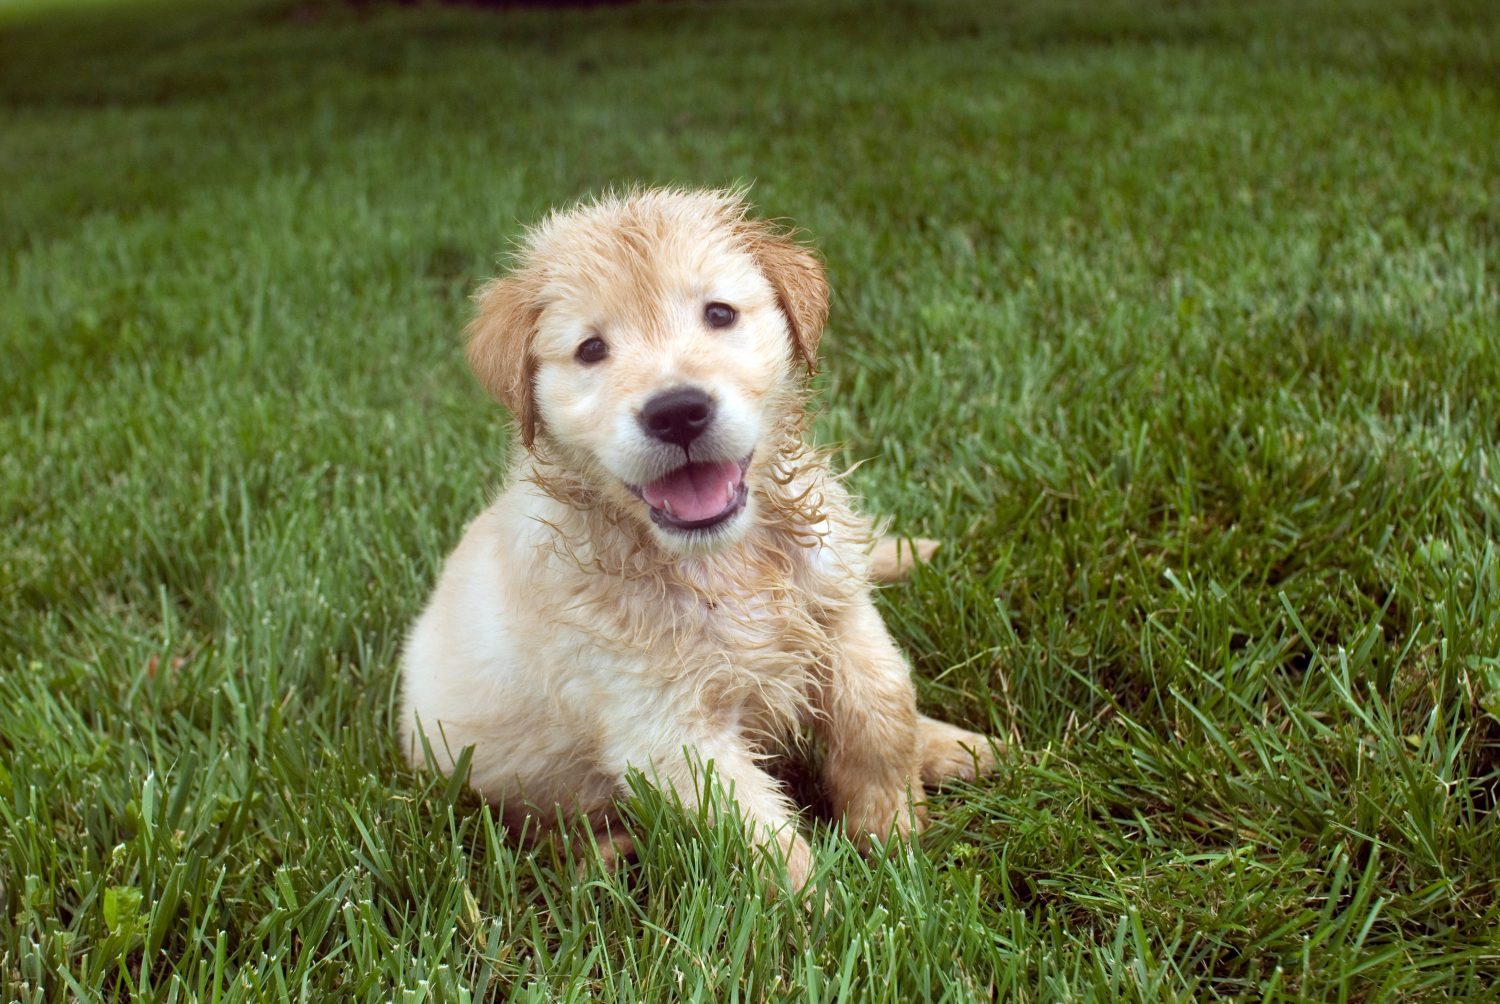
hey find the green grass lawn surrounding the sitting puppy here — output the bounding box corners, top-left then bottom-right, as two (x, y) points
(0, 0), (1500, 1001)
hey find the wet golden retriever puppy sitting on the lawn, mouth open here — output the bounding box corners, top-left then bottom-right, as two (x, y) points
(401, 189), (993, 885)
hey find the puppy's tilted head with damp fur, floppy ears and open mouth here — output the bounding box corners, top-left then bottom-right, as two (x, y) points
(468, 191), (828, 552)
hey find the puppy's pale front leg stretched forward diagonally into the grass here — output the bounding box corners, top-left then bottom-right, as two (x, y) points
(612, 726), (813, 888)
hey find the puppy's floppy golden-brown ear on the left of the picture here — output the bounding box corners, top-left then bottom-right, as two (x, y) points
(467, 276), (542, 449)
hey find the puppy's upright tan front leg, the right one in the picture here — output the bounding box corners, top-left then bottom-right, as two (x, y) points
(815, 596), (926, 846)
